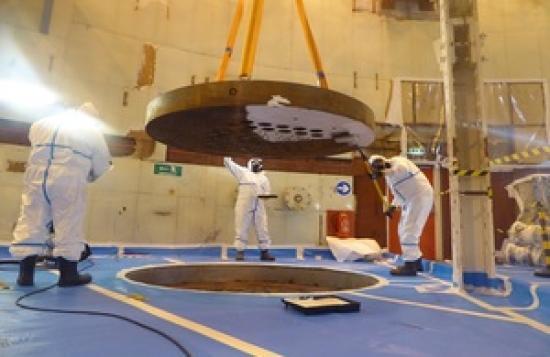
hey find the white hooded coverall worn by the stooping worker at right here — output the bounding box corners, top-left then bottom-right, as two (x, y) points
(384, 156), (433, 261)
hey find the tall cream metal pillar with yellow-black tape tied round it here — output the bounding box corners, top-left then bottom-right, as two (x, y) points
(440, 0), (495, 289)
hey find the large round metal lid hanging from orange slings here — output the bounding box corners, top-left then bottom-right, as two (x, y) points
(146, 80), (374, 158)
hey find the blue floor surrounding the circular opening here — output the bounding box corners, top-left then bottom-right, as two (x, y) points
(0, 250), (550, 357)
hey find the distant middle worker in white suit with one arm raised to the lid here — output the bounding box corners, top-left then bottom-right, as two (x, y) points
(223, 157), (275, 261)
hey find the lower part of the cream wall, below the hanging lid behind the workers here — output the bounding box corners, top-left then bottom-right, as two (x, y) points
(0, 145), (355, 245)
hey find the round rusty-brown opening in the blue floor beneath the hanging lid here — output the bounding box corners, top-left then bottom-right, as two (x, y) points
(123, 263), (379, 293)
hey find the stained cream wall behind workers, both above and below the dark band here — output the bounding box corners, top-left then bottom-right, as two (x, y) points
(0, 0), (550, 244)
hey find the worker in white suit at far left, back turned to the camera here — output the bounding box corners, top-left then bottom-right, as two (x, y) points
(10, 103), (111, 287)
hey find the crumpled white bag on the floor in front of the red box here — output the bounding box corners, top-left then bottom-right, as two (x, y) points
(327, 236), (381, 262)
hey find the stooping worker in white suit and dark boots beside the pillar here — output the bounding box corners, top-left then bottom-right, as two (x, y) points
(369, 155), (433, 276)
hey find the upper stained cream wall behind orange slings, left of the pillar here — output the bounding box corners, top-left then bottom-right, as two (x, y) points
(0, 0), (439, 127)
